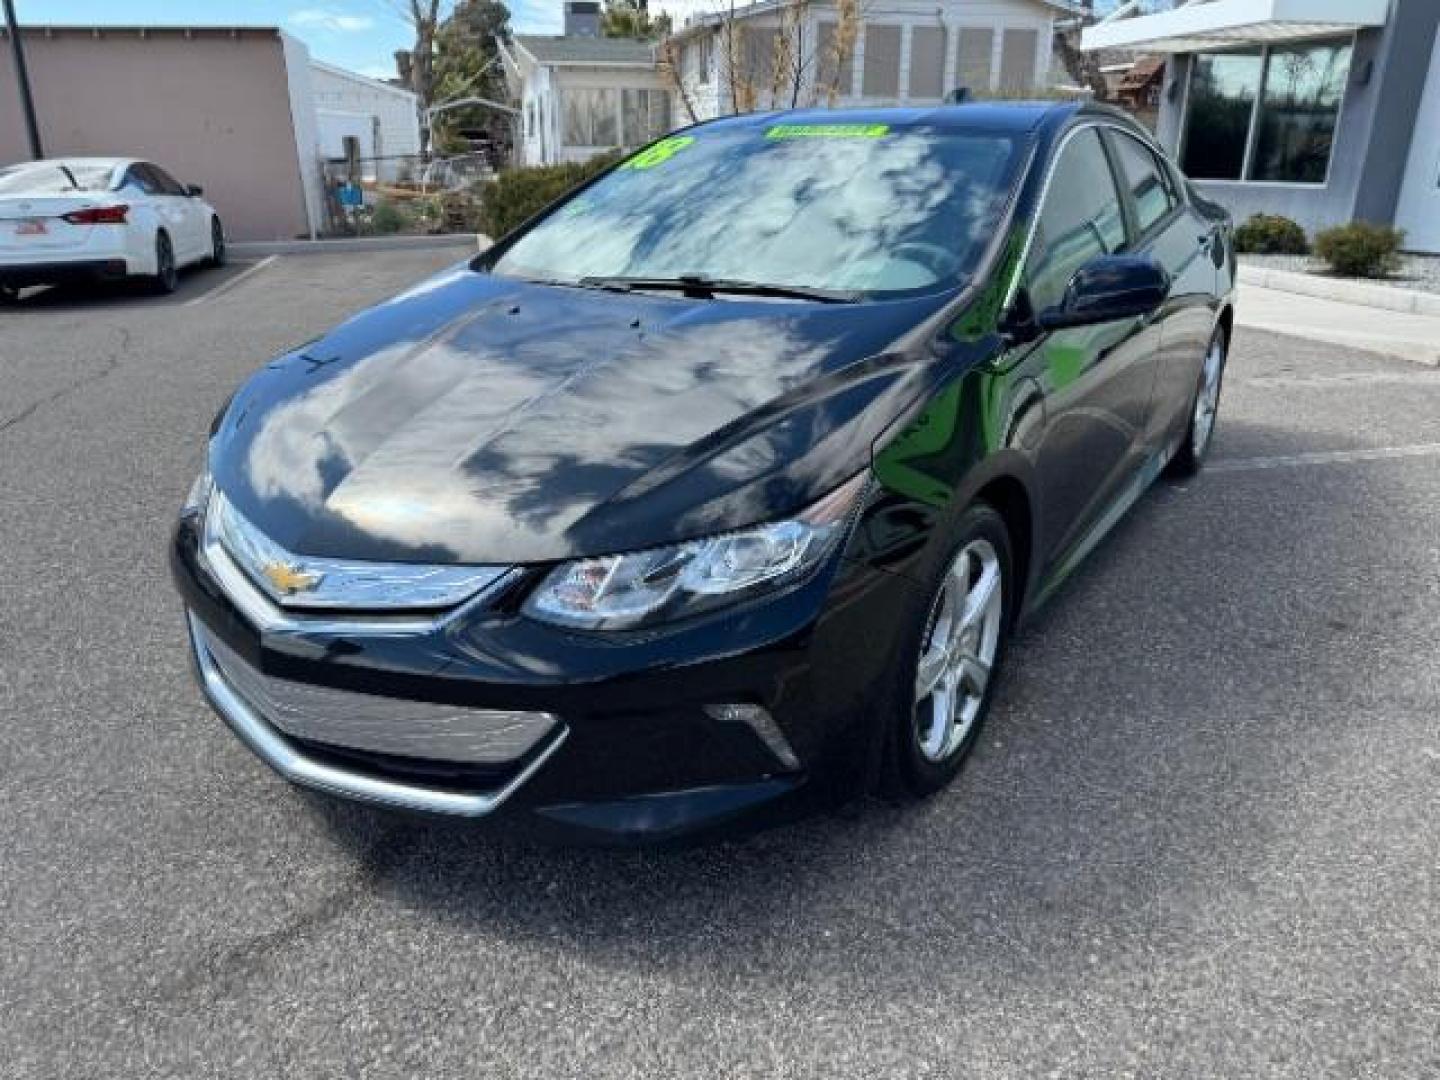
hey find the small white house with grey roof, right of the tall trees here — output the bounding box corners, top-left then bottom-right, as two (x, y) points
(500, 0), (674, 166)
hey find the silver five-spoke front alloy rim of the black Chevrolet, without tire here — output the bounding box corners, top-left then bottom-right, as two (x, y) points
(914, 539), (1005, 765)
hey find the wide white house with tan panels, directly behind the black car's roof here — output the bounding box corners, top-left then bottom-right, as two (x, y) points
(674, 0), (1077, 122)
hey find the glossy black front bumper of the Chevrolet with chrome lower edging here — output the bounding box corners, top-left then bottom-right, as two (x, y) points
(171, 509), (910, 842)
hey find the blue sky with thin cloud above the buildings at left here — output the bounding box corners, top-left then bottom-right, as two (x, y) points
(16, 0), (562, 78)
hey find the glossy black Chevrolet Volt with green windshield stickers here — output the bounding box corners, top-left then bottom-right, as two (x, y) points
(170, 104), (1236, 842)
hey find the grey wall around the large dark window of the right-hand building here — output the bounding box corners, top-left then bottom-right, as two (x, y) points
(1156, 0), (1440, 240)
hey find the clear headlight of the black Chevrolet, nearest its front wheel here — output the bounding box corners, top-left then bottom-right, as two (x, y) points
(524, 472), (867, 629)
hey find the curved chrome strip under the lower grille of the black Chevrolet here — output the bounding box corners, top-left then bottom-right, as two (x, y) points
(187, 615), (569, 818)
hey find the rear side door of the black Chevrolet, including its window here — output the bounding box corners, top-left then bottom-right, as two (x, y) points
(1106, 127), (1224, 454)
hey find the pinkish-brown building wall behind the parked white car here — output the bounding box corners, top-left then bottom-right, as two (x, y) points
(0, 29), (307, 239)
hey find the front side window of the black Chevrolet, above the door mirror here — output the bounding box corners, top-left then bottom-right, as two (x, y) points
(1025, 128), (1126, 311)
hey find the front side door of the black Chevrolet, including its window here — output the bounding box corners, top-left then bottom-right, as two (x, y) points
(1024, 124), (1161, 567)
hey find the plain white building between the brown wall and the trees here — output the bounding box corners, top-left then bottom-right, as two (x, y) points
(310, 60), (420, 180)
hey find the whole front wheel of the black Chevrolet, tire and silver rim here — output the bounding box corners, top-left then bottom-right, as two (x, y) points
(883, 503), (1017, 799)
